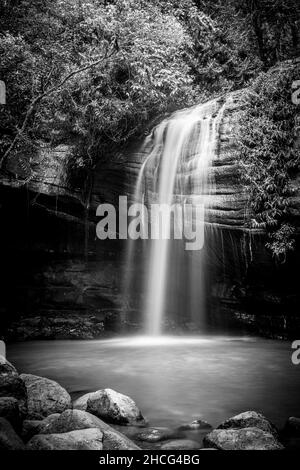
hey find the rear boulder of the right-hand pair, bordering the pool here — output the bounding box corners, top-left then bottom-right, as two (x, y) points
(217, 411), (278, 437)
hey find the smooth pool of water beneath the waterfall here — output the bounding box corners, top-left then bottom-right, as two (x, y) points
(7, 336), (300, 426)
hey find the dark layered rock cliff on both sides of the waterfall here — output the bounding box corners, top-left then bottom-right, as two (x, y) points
(0, 61), (300, 338)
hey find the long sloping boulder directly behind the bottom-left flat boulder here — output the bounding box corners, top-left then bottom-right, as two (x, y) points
(23, 410), (139, 450)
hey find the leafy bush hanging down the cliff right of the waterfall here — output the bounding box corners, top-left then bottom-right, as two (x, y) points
(238, 65), (300, 260)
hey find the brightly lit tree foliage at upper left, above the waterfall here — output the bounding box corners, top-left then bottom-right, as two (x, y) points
(0, 0), (196, 174)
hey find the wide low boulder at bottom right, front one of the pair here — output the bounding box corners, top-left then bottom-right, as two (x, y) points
(203, 427), (284, 450)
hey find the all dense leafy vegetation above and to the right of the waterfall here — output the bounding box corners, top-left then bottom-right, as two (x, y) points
(0, 0), (300, 255)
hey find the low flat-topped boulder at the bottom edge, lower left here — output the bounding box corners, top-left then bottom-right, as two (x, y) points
(26, 428), (103, 450)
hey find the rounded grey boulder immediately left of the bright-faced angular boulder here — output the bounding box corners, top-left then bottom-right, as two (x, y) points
(20, 374), (72, 419)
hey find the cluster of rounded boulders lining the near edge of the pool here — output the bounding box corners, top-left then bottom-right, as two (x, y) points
(0, 356), (300, 450)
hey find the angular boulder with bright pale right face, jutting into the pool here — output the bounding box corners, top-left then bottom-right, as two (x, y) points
(86, 388), (145, 424)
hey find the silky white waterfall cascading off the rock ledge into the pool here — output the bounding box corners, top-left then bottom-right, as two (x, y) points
(126, 101), (223, 336)
